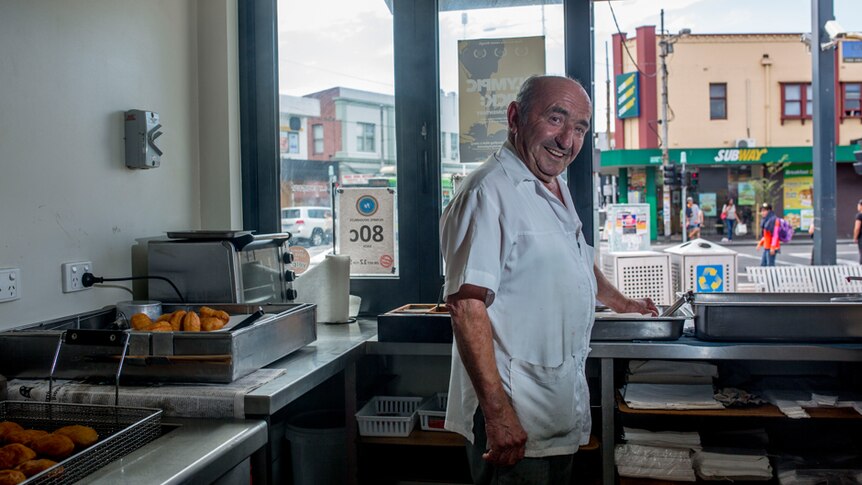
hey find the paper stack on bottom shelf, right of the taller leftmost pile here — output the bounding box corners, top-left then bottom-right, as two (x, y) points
(694, 450), (772, 481)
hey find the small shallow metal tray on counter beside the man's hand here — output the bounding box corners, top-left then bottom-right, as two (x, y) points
(590, 313), (686, 341)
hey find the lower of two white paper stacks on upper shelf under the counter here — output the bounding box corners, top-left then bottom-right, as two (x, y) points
(623, 383), (724, 409)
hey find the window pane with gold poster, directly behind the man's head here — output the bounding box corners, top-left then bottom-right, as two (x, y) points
(439, 1), (565, 210)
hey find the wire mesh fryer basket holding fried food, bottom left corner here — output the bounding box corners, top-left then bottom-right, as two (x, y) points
(0, 401), (162, 485)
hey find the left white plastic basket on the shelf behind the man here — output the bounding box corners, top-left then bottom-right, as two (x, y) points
(356, 396), (422, 437)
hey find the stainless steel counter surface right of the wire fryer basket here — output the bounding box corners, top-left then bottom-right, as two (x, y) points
(79, 418), (267, 485)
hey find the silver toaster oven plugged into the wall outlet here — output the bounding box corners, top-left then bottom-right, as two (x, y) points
(147, 231), (296, 303)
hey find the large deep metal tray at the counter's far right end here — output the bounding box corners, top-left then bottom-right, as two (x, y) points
(691, 293), (862, 342)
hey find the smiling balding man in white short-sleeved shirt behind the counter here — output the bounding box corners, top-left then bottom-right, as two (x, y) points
(440, 76), (657, 484)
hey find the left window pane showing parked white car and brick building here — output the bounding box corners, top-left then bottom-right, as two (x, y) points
(277, 0), (397, 264)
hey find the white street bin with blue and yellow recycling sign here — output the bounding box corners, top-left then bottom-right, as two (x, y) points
(664, 239), (737, 293)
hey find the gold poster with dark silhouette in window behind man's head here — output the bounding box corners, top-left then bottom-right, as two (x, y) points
(458, 36), (545, 163)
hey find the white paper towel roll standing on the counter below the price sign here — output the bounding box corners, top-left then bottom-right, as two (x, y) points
(293, 254), (350, 323)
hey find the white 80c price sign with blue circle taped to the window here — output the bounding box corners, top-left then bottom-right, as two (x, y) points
(335, 187), (398, 276)
